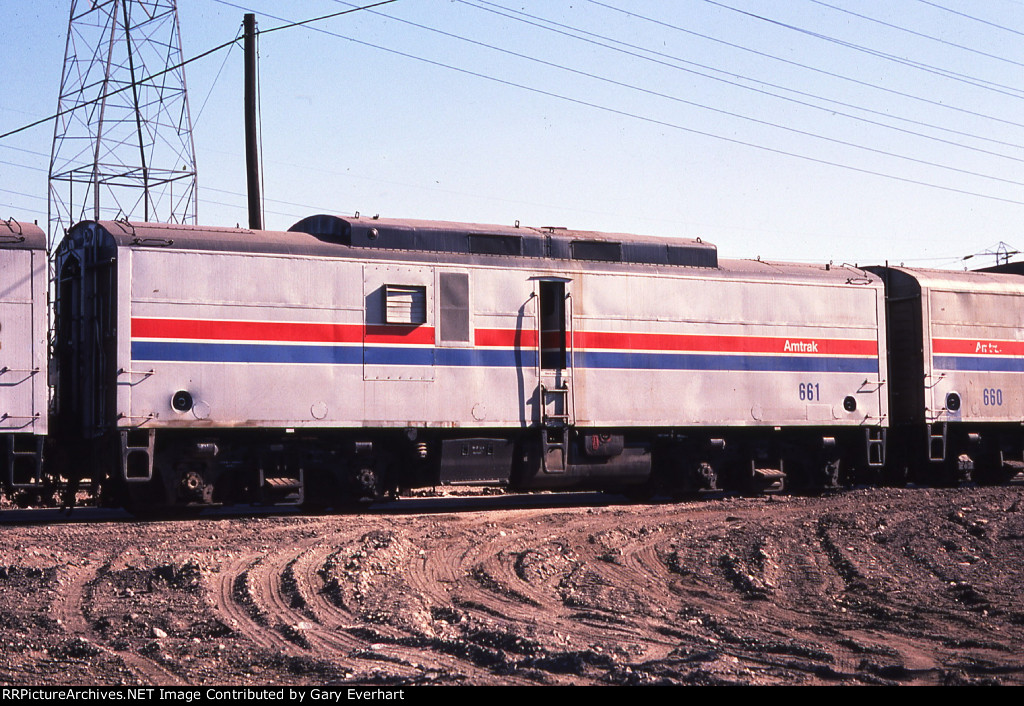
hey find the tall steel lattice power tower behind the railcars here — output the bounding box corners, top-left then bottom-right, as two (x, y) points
(48, 0), (197, 246)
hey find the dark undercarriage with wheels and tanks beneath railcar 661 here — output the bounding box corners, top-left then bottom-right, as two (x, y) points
(8, 418), (946, 513)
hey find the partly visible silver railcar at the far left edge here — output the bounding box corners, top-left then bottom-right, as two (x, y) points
(0, 220), (48, 490)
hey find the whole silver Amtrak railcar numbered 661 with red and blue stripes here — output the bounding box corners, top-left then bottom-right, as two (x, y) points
(55, 216), (888, 507)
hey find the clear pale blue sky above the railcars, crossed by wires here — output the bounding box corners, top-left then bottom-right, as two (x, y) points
(0, 0), (1024, 266)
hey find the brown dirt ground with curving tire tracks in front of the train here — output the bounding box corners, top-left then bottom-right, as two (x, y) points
(0, 488), (1024, 686)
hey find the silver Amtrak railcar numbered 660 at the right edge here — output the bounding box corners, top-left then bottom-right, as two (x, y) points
(872, 267), (1024, 483)
